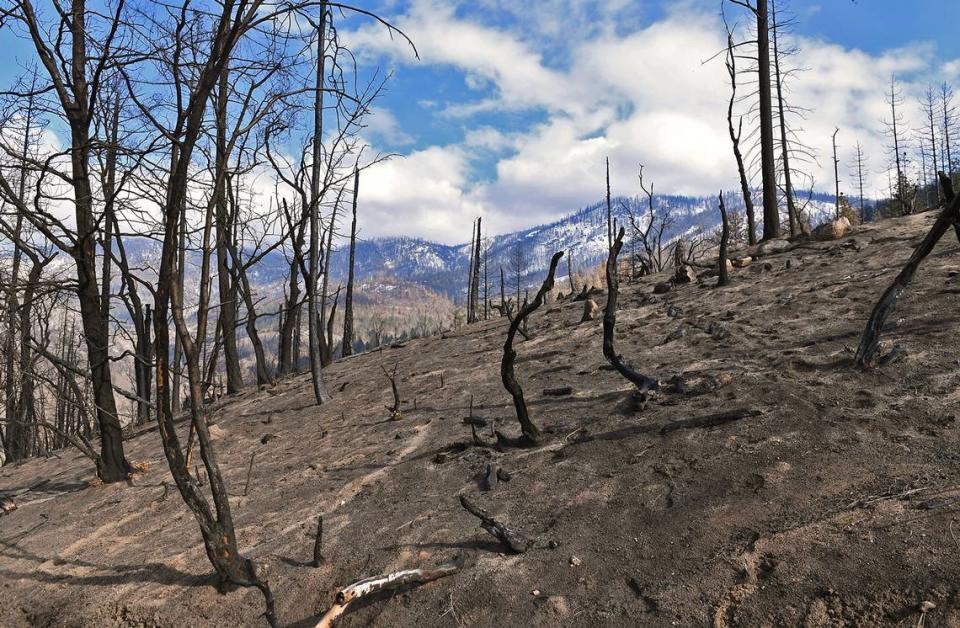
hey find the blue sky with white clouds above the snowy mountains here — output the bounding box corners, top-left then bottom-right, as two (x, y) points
(0, 0), (960, 242)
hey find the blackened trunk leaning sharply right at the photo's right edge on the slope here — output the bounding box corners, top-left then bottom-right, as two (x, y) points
(854, 172), (960, 368)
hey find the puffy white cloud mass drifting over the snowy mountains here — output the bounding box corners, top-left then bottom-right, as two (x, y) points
(345, 0), (960, 242)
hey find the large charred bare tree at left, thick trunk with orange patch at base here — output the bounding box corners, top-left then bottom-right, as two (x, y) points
(0, 0), (132, 482)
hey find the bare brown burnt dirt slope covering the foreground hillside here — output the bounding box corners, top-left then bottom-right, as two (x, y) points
(0, 214), (960, 628)
